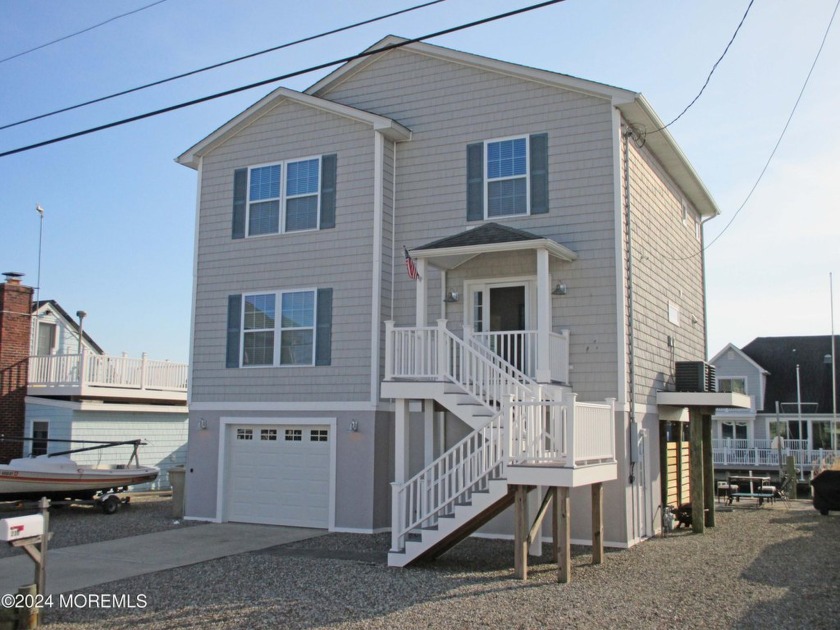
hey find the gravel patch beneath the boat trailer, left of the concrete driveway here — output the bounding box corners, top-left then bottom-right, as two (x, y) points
(0, 493), (201, 558)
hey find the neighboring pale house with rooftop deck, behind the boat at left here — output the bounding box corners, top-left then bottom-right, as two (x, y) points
(23, 300), (187, 490)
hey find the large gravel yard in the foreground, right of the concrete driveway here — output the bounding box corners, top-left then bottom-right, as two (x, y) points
(24, 501), (840, 630)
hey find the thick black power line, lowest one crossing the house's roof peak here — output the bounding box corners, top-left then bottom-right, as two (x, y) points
(0, 0), (566, 158)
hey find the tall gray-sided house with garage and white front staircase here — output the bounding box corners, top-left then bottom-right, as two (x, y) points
(178, 37), (718, 564)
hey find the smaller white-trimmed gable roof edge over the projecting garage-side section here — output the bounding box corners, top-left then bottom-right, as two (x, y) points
(175, 87), (411, 169)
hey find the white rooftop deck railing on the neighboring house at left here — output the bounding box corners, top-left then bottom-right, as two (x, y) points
(29, 353), (187, 392)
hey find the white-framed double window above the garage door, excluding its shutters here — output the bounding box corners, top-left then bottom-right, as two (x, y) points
(242, 290), (317, 366)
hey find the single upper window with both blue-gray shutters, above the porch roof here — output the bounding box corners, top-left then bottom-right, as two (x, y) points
(467, 133), (549, 221)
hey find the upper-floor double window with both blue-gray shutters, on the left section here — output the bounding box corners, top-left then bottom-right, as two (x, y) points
(232, 155), (337, 239)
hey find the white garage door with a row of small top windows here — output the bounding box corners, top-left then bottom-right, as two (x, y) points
(227, 425), (332, 528)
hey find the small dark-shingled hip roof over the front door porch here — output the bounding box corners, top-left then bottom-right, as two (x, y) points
(411, 222), (577, 270)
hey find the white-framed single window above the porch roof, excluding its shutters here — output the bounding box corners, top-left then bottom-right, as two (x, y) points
(485, 137), (529, 218)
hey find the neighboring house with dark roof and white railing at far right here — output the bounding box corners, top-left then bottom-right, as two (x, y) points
(711, 335), (840, 472)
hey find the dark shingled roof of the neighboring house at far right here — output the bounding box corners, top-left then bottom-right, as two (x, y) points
(743, 335), (840, 413)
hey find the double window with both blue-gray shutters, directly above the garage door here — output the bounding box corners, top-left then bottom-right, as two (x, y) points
(231, 289), (332, 367)
